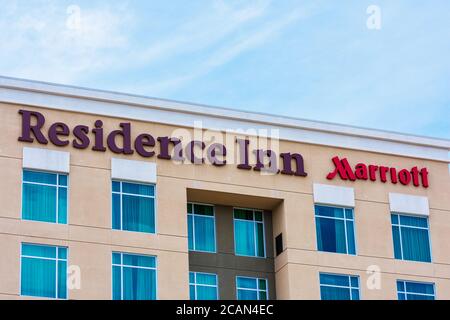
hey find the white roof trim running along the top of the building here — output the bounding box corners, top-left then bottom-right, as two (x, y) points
(0, 77), (450, 162)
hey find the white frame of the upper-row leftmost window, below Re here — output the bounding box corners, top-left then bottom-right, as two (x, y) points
(20, 168), (70, 226)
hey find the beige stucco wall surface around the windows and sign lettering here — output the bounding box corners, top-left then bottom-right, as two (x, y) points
(0, 104), (450, 299)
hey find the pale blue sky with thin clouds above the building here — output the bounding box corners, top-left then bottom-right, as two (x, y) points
(0, 0), (450, 139)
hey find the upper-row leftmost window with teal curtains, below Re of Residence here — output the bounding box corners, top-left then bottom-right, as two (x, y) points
(22, 170), (67, 224)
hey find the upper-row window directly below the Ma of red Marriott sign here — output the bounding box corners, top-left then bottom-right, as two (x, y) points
(315, 206), (356, 254)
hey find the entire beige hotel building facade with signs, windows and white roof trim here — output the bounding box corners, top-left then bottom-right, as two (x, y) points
(0, 78), (450, 300)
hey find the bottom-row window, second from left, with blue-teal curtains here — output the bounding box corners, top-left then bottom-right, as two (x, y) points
(112, 252), (156, 300)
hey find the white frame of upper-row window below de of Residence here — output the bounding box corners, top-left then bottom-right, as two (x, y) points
(110, 179), (158, 235)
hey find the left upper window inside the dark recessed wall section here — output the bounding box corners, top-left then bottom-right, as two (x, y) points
(187, 203), (216, 252)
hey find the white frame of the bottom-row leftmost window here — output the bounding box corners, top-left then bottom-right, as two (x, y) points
(19, 242), (69, 300)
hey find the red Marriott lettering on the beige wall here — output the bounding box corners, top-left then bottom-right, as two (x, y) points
(327, 157), (429, 188)
